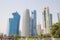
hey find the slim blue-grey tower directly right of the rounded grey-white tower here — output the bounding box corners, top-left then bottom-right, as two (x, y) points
(30, 10), (37, 36)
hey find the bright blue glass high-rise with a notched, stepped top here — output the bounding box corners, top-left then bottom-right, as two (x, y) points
(8, 12), (20, 36)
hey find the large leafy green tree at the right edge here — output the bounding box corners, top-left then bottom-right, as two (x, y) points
(50, 22), (60, 38)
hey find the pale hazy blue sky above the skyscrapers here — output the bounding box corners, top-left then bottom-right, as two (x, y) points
(0, 0), (60, 34)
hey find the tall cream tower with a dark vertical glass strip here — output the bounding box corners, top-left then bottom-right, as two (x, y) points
(42, 7), (50, 34)
